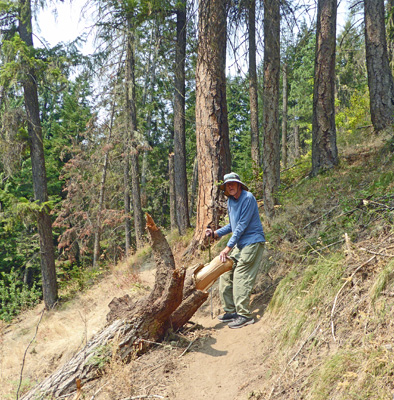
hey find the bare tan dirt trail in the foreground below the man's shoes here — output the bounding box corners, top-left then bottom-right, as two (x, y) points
(169, 317), (263, 400)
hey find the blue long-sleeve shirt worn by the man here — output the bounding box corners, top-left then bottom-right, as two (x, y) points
(216, 190), (265, 249)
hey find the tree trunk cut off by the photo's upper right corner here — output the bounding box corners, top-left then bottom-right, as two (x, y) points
(364, 0), (394, 131)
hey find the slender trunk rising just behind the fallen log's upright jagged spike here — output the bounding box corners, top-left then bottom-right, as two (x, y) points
(126, 21), (144, 249)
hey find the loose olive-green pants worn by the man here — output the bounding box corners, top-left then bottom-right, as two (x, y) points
(219, 242), (264, 318)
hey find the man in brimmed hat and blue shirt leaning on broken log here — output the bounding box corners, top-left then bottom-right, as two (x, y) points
(206, 172), (265, 328)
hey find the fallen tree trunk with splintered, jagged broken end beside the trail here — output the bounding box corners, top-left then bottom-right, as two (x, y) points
(21, 215), (233, 400)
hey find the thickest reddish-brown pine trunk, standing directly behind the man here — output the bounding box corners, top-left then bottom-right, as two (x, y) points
(192, 0), (231, 247)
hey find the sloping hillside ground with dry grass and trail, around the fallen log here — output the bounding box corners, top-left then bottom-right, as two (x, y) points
(0, 130), (394, 400)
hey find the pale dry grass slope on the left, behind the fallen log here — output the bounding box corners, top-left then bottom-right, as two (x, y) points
(0, 261), (153, 399)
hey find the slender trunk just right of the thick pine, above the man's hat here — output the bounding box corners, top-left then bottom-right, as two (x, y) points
(248, 0), (261, 191)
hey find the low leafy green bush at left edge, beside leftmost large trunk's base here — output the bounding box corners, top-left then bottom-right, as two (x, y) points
(0, 268), (41, 321)
